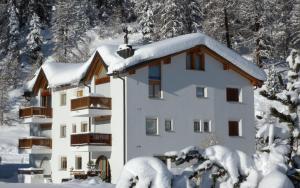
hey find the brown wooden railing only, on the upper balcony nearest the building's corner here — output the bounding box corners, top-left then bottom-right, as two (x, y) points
(71, 96), (111, 111)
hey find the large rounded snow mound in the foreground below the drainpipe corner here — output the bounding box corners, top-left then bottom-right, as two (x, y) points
(116, 157), (172, 188)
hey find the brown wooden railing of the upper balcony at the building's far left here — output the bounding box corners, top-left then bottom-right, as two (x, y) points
(19, 107), (52, 118)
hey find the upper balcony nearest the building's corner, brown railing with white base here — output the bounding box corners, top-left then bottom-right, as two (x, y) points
(71, 96), (111, 117)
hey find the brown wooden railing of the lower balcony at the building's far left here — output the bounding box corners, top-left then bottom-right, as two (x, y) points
(19, 138), (52, 149)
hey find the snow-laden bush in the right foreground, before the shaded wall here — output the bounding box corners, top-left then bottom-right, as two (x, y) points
(166, 143), (293, 188)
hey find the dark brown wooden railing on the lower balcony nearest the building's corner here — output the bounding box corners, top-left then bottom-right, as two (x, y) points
(71, 133), (111, 146)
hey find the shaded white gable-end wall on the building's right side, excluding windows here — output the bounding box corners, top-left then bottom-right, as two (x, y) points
(125, 54), (255, 159)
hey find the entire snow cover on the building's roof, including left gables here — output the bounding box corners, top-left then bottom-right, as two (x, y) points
(27, 33), (266, 89)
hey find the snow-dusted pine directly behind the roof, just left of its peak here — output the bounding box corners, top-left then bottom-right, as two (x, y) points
(159, 0), (186, 38)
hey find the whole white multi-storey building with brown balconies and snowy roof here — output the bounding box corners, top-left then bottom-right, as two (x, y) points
(19, 33), (266, 183)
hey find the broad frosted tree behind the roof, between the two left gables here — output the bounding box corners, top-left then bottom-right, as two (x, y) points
(52, 0), (90, 63)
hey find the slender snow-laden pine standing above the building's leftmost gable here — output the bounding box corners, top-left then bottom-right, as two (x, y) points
(27, 13), (43, 65)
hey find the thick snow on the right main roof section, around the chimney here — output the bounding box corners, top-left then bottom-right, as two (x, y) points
(97, 33), (266, 80)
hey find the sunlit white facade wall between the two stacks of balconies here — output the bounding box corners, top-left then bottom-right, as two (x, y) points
(51, 87), (89, 183)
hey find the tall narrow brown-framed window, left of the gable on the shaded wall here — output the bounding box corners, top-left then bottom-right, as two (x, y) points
(148, 64), (161, 98)
